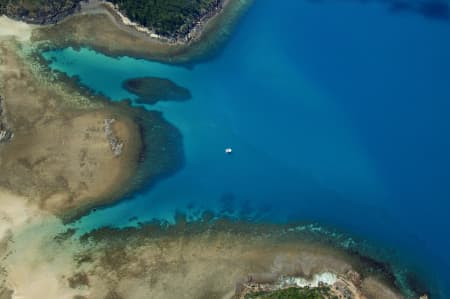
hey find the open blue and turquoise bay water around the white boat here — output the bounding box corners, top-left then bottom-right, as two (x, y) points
(45, 0), (450, 298)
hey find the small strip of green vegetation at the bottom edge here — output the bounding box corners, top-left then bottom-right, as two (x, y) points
(245, 287), (334, 299)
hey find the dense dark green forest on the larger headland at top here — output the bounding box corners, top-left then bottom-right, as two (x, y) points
(110, 0), (222, 37)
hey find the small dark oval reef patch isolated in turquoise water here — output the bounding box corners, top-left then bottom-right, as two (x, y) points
(122, 77), (192, 104)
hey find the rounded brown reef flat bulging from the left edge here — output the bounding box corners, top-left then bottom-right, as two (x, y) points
(0, 42), (141, 218)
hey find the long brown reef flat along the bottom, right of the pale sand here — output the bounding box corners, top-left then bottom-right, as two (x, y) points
(18, 220), (403, 299)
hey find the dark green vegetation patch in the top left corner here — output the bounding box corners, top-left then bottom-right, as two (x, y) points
(0, 0), (81, 24)
